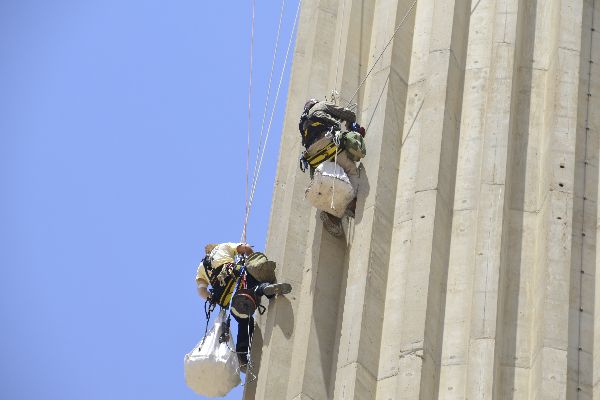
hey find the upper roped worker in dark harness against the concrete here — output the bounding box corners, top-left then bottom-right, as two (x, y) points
(298, 99), (366, 236)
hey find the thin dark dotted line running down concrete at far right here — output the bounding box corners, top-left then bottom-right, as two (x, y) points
(577, 0), (596, 399)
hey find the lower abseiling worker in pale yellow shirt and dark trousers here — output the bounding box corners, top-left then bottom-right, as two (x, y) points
(196, 243), (292, 365)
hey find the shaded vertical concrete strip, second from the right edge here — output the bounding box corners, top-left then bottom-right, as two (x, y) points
(493, 0), (537, 400)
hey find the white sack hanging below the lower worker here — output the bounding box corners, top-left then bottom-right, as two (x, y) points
(183, 310), (241, 397)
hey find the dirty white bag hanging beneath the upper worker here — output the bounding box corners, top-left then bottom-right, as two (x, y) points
(305, 161), (356, 218)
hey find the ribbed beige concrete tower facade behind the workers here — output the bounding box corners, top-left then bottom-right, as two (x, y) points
(245, 0), (600, 400)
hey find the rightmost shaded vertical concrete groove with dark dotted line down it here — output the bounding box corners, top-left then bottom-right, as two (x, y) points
(568, 1), (600, 399)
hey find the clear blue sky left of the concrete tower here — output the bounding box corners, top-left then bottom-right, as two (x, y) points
(0, 0), (298, 400)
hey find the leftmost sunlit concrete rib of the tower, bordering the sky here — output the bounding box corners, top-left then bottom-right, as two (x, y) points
(245, 0), (344, 399)
